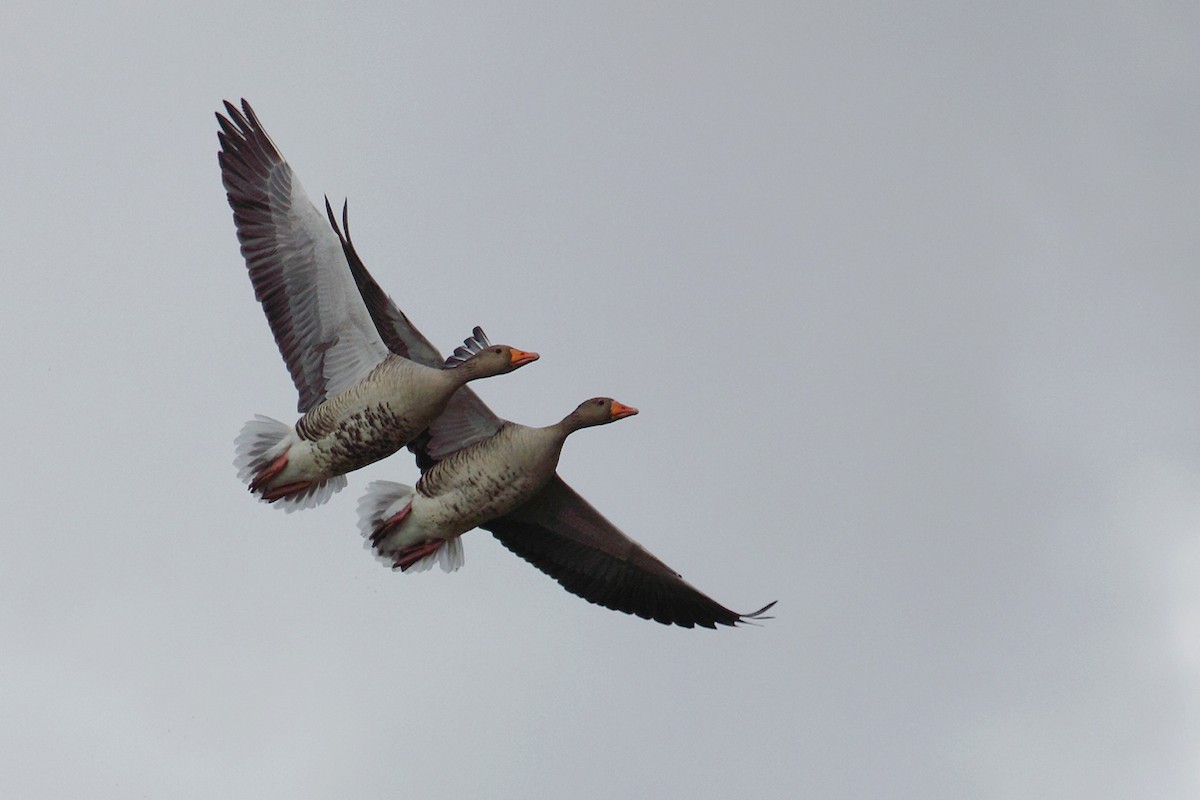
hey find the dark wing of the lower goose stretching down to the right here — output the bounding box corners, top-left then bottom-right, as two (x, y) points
(480, 475), (775, 627)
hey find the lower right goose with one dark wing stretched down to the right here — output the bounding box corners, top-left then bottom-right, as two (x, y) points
(341, 220), (775, 627)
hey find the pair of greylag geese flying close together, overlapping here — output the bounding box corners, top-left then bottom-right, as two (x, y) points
(217, 101), (774, 627)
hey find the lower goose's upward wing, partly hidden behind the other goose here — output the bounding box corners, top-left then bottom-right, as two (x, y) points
(325, 198), (504, 471)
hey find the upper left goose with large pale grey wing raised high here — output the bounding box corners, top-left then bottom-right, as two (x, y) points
(216, 101), (538, 511)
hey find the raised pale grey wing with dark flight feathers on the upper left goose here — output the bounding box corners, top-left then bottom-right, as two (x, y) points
(217, 101), (388, 413)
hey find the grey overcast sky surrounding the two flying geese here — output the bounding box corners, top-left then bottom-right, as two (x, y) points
(0, 0), (1200, 800)
